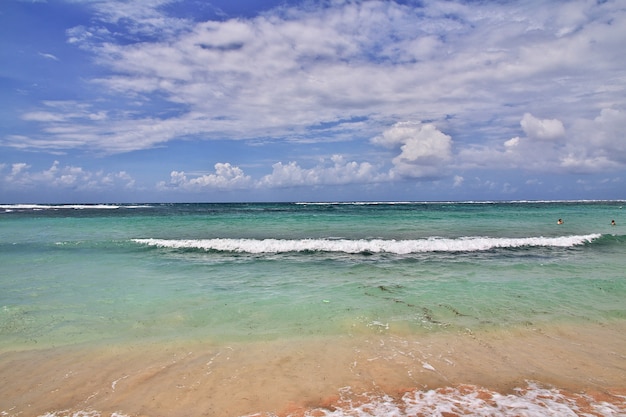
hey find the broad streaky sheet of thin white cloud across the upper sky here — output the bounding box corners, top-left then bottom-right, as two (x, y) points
(11, 0), (626, 156)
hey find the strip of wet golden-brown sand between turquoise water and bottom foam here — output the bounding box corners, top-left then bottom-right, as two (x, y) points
(0, 321), (626, 417)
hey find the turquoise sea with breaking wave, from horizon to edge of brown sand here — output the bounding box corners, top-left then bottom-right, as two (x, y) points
(0, 201), (626, 350)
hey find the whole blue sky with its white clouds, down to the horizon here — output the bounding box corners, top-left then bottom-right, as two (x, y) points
(0, 0), (626, 203)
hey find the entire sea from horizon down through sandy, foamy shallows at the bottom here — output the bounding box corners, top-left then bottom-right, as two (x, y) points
(0, 201), (626, 417)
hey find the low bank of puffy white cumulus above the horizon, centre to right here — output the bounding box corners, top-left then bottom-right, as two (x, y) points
(149, 105), (624, 193)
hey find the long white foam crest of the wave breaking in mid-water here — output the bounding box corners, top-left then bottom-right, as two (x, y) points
(133, 234), (601, 254)
